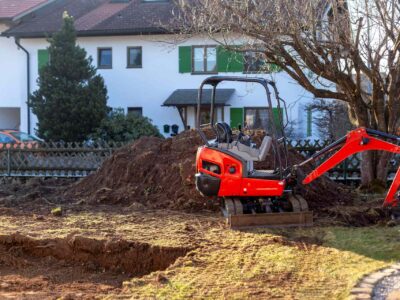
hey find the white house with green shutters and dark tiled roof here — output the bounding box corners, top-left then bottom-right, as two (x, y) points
(0, 0), (317, 137)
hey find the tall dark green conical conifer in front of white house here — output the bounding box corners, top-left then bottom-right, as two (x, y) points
(29, 14), (109, 142)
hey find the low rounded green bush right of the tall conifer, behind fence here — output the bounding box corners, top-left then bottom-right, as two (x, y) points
(90, 108), (162, 142)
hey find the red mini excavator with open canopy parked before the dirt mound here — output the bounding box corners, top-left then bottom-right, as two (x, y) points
(195, 76), (400, 228)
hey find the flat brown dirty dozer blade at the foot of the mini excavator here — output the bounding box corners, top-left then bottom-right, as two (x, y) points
(227, 211), (313, 229)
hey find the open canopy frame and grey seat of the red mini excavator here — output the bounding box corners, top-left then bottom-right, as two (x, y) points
(197, 76), (287, 179)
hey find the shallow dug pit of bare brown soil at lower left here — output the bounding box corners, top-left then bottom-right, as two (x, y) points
(0, 234), (189, 299)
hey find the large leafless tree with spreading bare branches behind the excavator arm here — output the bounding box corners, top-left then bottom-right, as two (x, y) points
(178, 0), (400, 186)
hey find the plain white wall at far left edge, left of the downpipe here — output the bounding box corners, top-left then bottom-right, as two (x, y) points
(0, 23), (26, 128)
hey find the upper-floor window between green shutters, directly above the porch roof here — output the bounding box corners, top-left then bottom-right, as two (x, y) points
(192, 46), (217, 73)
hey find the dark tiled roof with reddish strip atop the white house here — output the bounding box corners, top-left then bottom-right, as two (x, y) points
(4, 0), (176, 37)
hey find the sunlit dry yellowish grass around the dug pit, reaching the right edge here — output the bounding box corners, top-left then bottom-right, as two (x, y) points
(0, 208), (400, 299)
